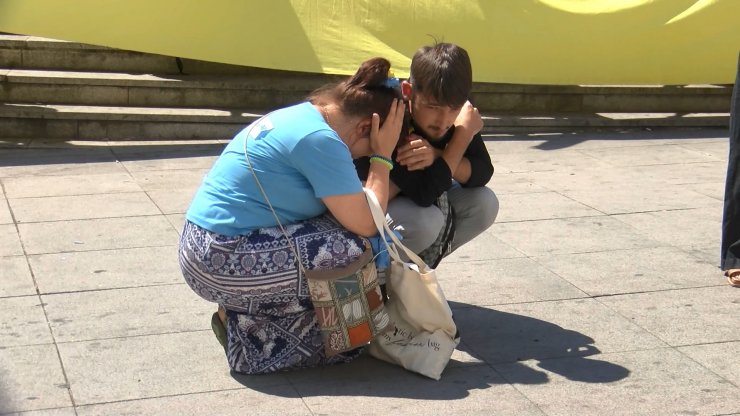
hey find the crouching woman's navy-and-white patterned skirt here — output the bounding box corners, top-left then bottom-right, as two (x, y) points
(179, 216), (366, 374)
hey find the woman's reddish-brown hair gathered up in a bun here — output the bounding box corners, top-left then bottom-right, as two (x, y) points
(308, 58), (402, 123)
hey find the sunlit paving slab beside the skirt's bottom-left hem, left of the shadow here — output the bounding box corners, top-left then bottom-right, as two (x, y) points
(58, 330), (287, 405)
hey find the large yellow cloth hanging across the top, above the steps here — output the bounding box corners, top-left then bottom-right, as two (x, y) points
(0, 0), (740, 84)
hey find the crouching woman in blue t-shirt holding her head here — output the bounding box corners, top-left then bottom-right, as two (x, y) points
(179, 58), (404, 373)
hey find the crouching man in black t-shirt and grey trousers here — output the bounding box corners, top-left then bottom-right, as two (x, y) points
(355, 43), (499, 264)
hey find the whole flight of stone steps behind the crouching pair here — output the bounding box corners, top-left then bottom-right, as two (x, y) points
(0, 34), (731, 140)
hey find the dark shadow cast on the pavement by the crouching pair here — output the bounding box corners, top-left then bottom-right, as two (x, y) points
(232, 302), (630, 400)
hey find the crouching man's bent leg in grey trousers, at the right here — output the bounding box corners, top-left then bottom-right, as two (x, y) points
(447, 183), (499, 251)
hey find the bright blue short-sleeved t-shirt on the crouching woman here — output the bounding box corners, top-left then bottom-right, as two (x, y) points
(185, 102), (362, 236)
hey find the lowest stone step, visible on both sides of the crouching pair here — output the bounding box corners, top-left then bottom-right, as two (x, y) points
(0, 104), (729, 140)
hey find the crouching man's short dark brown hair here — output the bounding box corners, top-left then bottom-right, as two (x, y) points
(409, 43), (473, 107)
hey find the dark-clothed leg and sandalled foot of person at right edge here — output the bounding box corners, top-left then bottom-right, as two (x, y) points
(720, 50), (740, 287)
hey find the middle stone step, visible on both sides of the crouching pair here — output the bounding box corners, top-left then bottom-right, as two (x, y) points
(0, 68), (732, 113)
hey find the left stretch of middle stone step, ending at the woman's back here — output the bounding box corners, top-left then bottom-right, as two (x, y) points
(0, 69), (338, 108)
